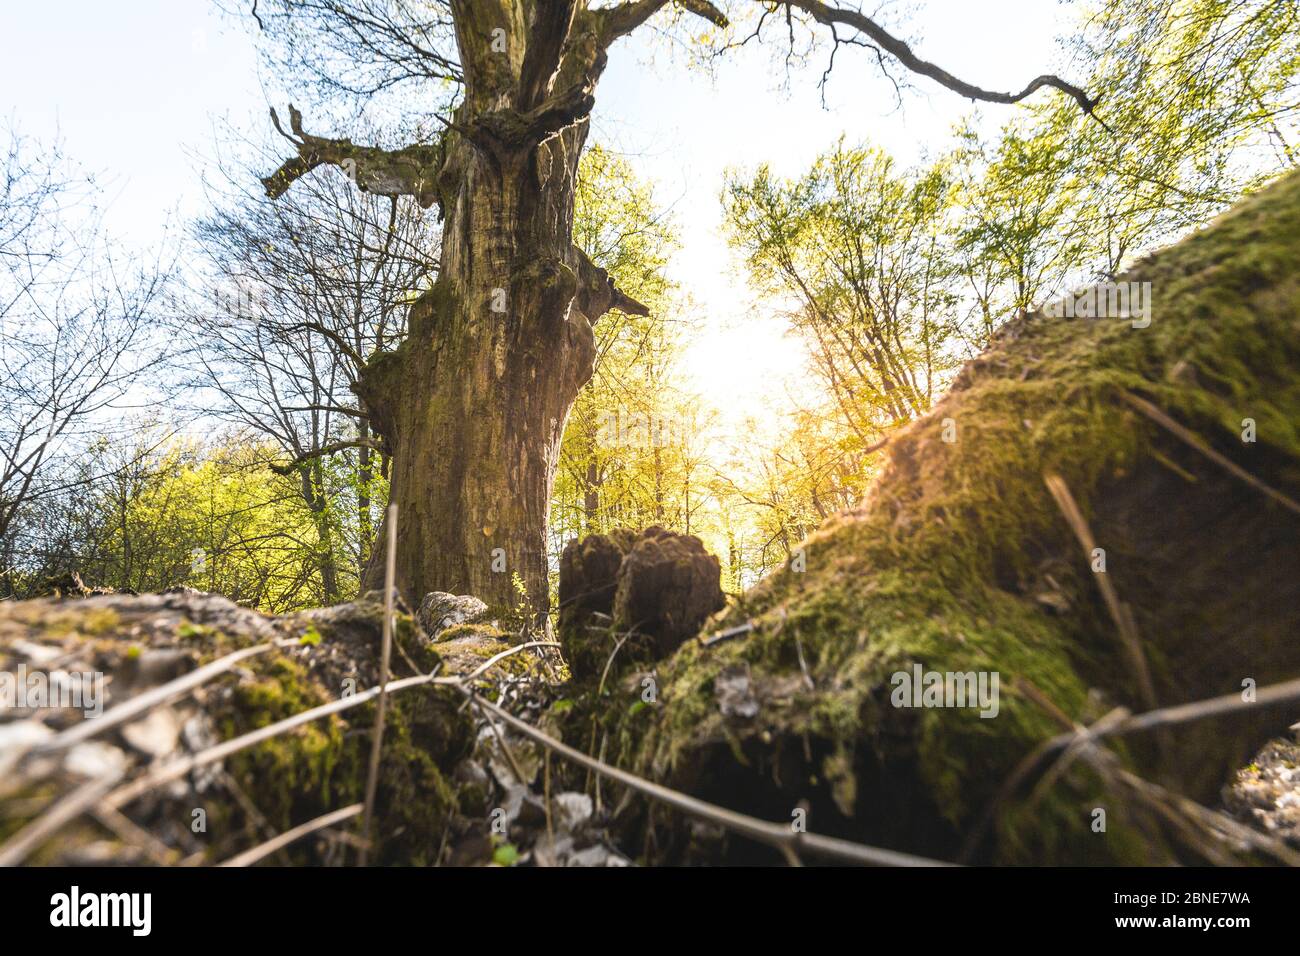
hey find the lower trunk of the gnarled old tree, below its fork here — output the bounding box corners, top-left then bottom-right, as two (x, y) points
(365, 129), (595, 607)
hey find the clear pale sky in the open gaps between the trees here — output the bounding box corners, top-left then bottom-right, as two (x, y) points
(0, 0), (1073, 418)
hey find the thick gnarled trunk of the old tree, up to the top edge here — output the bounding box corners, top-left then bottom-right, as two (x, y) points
(358, 3), (638, 614)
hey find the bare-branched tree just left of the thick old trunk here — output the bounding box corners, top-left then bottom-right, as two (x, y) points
(189, 140), (438, 601)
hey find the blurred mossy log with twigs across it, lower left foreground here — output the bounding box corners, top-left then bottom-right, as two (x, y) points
(0, 592), (478, 864)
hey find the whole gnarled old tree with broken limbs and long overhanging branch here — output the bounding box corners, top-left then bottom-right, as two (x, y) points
(254, 0), (1095, 611)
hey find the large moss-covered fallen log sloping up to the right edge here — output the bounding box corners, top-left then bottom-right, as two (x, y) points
(567, 174), (1300, 864)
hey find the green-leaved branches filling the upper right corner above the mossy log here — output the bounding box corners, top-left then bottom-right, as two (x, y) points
(953, 0), (1300, 325)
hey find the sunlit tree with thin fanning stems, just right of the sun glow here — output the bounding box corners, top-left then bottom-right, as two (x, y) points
(725, 143), (956, 447)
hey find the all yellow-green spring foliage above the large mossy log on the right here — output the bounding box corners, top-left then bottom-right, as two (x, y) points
(720, 0), (1300, 590)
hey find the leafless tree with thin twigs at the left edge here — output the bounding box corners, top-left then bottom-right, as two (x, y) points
(0, 134), (169, 566)
